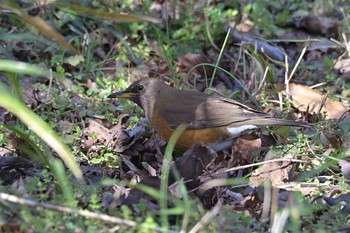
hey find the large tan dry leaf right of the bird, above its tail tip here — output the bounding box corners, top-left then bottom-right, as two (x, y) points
(289, 83), (349, 119)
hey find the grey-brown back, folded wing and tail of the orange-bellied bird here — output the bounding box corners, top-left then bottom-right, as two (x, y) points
(156, 85), (306, 130)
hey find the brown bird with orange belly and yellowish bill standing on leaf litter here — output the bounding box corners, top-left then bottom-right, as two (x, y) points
(107, 78), (308, 150)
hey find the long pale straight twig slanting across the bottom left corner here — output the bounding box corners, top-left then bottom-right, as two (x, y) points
(0, 193), (168, 232)
